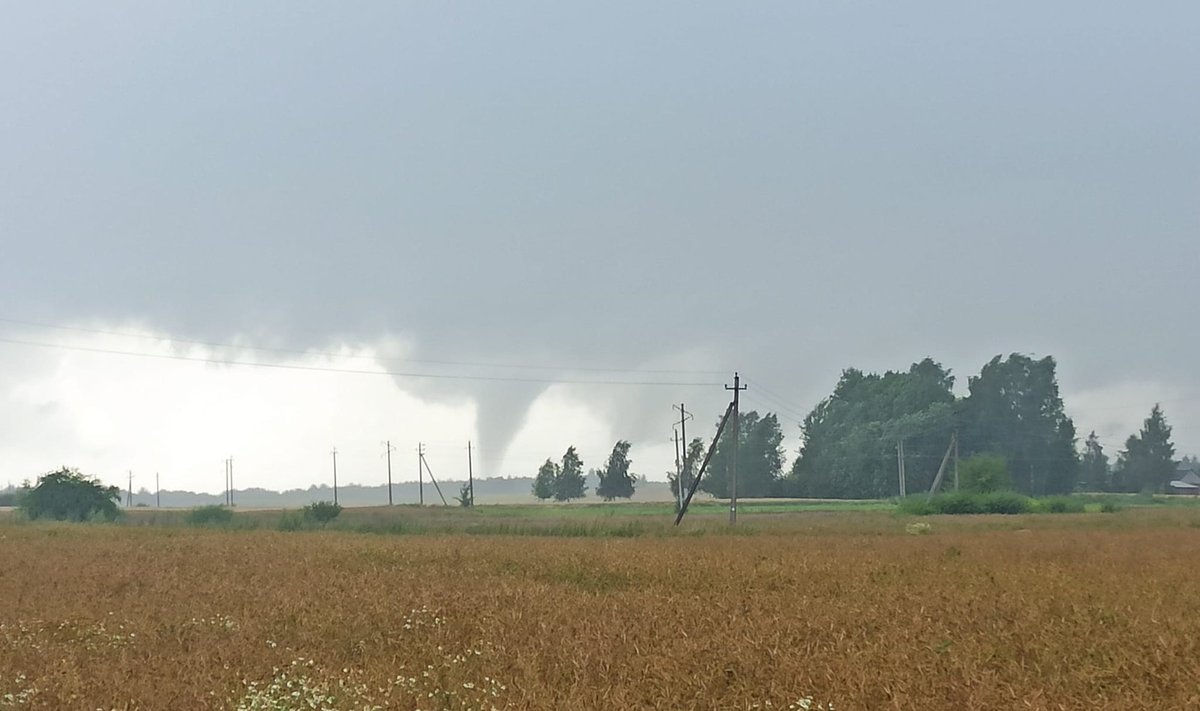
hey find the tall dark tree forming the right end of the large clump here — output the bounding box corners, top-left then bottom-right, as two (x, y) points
(959, 353), (1079, 495)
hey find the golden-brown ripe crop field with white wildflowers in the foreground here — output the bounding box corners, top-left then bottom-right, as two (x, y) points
(0, 510), (1200, 710)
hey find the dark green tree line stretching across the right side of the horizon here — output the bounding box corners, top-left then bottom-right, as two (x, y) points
(668, 353), (1177, 498)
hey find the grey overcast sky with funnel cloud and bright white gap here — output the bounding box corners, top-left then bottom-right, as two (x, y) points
(0, 0), (1200, 491)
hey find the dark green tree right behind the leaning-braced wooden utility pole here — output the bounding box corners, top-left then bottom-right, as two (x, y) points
(700, 410), (784, 498)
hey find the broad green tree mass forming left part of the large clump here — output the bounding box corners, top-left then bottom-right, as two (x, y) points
(785, 358), (954, 498)
